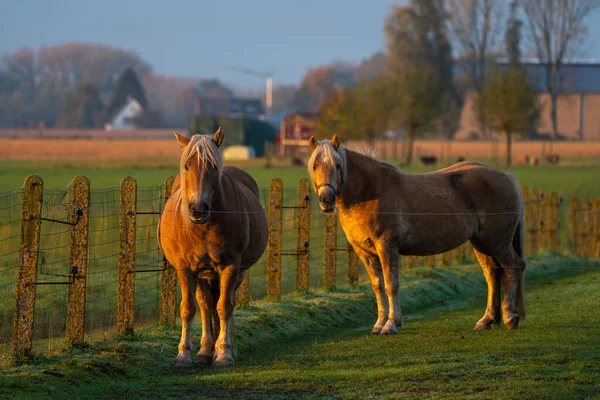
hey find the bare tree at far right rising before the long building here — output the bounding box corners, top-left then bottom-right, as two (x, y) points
(520, 0), (600, 138)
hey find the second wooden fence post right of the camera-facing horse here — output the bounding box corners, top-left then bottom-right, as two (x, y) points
(296, 178), (310, 292)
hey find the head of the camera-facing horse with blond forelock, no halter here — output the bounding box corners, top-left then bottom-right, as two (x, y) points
(175, 128), (224, 224)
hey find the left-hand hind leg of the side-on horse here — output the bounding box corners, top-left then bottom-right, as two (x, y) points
(475, 249), (503, 331)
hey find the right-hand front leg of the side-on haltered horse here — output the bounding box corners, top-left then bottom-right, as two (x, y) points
(377, 241), (402, 335)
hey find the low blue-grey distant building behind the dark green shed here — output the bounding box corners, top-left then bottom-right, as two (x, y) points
(194, 96), (265, 119)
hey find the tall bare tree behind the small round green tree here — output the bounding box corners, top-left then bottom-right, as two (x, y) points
(447, 0), (507, 136)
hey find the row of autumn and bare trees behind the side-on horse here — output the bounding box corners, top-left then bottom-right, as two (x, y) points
(314, 0), (600, 165)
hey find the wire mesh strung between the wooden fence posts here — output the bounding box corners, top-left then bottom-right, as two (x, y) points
(0, 177), (598, 352)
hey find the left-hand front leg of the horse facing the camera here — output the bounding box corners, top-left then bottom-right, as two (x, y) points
(175, 268), (198, 367)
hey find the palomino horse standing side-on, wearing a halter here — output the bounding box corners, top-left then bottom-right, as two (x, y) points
(308, 135), (525, 335)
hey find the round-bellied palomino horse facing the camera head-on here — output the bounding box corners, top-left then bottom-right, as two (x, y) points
(158, 128), (268, 367)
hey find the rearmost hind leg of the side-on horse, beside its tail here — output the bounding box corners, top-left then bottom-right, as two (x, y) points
(494, 244), (525, 329)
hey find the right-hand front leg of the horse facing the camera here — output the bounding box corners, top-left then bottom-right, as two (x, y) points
(215, 263), (241, 366)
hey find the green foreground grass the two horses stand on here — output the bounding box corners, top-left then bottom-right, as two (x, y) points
(0, 256), (600, 399)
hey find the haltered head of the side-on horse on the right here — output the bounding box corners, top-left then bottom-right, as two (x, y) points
(308, 135), (346, 213)
